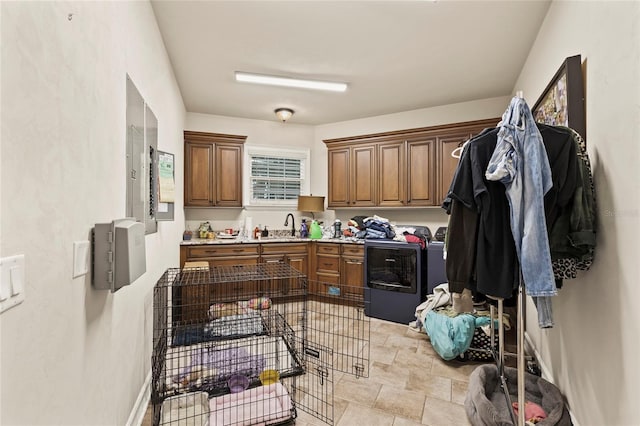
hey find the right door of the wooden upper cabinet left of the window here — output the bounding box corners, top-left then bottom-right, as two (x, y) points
(215, 144), (242, 207)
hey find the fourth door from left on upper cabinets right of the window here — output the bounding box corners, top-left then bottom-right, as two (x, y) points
(407, 138), (436, 206)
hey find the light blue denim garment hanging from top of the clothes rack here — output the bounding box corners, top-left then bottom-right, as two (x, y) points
(485, 97), (557, 327)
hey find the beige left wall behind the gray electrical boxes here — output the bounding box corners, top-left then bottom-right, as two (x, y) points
(0, 2), (185, 425)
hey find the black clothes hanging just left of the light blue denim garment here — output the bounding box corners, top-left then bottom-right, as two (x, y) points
(442, 128), (518, 299)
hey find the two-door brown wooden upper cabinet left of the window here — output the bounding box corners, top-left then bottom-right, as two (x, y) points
(184, 131), (247, 207)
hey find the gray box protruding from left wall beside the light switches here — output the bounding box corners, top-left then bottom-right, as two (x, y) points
(92, 218), (147, 293)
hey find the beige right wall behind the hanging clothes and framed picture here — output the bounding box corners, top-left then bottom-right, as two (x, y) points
(514, 1), (640, 426)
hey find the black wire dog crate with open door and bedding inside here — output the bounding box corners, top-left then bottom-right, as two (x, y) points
(151, 263), (369, 426)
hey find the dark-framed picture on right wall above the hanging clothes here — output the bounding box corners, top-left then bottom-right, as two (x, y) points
(532, 55), (587, 141)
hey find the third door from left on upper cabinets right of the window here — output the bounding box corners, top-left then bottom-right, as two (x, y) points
(376, 141), (406, 207)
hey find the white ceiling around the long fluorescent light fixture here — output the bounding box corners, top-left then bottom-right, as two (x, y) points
(152, 0), (550, 124)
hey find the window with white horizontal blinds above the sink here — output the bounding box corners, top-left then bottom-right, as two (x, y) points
(250, 154), (305, 203)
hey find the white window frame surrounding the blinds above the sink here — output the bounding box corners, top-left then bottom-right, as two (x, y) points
(243, 145), (310, 209)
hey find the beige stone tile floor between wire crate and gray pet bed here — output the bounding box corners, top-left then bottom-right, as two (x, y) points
(143, 318), (490, 426)
